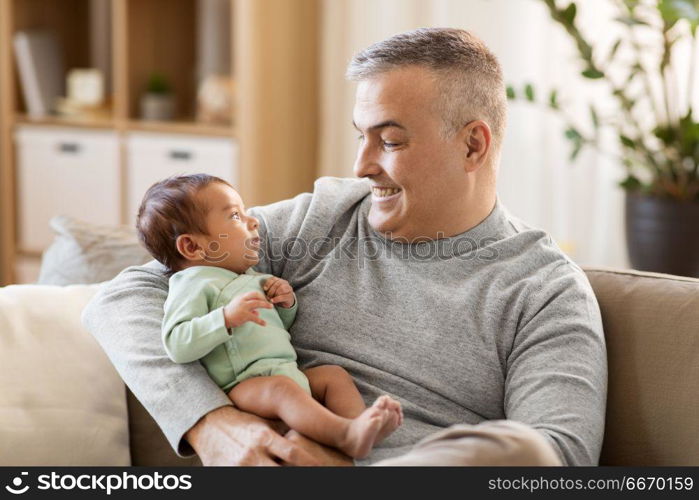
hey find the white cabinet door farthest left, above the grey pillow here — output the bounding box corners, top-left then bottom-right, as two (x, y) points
(15, 126), (121, 252)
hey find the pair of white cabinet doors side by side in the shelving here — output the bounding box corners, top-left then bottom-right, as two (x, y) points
(15, 125), (238, 253)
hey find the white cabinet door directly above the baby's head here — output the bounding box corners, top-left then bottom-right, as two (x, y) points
(127, 133), (238, 224)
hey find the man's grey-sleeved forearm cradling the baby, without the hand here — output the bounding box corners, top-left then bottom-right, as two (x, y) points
(83, 264), (231, 454)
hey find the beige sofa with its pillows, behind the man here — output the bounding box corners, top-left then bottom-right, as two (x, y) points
(0, 217), (699, 466)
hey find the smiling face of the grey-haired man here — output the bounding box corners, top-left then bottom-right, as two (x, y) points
(354, 66), (468, 240)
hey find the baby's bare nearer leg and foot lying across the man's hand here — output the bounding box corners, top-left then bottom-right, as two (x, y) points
(228, 375), (390, 458)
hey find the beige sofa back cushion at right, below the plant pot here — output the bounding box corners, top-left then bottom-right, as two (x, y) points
(585, 269), (699, 465)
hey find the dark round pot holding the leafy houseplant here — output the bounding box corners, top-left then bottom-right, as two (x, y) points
(626, 192), (699, 278)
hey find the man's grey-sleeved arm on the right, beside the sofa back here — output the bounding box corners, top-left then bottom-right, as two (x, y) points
(504, 263), (607, 465)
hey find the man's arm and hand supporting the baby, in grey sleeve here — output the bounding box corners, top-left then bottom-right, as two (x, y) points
(83, 262), (317, 465)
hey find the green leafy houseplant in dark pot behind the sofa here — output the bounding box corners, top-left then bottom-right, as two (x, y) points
(507, 0), (699, 277)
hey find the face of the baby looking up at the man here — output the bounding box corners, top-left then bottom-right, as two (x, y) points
(197, 182), (260, 274)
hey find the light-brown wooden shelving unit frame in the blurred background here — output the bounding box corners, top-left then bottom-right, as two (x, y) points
(0, 0), (320, 285)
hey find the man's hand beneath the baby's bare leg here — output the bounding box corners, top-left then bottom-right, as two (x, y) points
(185, 406), (320, 466)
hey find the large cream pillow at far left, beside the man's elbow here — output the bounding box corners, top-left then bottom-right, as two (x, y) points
(0, 285), (130, 466)
